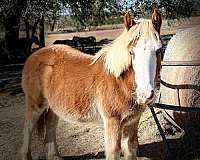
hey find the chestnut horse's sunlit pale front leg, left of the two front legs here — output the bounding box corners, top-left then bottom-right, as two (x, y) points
(104, 117), (121, 160)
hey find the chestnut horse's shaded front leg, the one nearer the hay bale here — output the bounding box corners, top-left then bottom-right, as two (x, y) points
(122, 117), (140, 160)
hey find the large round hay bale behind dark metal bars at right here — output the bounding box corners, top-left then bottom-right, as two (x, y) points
(160, 26), (200, 129)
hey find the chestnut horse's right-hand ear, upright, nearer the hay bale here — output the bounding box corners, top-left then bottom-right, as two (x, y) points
(151, 8), (162, 34)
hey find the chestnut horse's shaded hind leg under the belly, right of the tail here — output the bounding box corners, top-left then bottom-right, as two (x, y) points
(45, 109), (62, 160)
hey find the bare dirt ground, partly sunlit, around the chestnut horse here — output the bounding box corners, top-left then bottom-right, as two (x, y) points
(0, 17), (200, 160)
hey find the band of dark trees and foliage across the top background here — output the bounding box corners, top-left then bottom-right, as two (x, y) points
(0, 0), (200, 60)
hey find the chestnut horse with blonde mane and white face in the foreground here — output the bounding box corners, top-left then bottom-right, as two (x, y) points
(21, 10), (162, 160)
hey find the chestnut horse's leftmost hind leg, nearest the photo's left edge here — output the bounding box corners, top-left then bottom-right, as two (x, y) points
(21, 97), (45, 160)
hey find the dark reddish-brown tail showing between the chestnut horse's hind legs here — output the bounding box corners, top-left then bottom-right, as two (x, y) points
(37, 110), (48, 139)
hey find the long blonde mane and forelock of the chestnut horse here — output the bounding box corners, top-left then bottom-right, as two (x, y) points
(92, 19), (159, 78)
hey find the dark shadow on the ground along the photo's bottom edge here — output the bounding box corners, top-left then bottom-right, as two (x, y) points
(50, 137), (200, 160)
